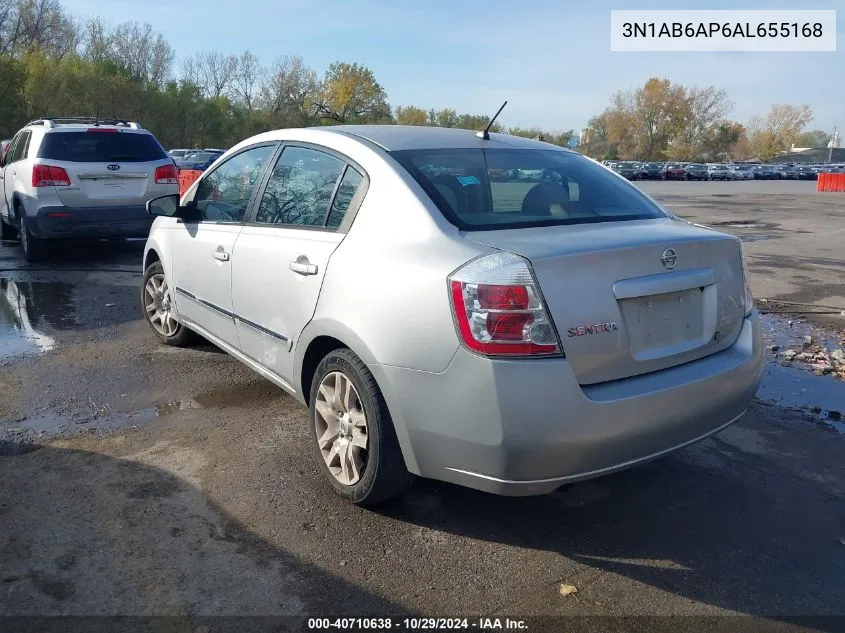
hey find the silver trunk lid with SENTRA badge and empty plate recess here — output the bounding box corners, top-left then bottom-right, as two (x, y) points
(465, 219), (744, 385)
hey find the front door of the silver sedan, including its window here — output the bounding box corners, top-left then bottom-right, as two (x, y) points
(173, 144), (276, 347)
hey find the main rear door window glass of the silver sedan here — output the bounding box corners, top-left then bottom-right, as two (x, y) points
(255, 147), (345, 226)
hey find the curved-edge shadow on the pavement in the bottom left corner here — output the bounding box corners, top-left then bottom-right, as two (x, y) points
(0, 442), (408, 632)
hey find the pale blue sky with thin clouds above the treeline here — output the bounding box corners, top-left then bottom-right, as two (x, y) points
(63, 0), (845, 131)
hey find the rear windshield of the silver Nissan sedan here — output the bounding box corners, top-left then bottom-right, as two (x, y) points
(392, 149), (665, 230)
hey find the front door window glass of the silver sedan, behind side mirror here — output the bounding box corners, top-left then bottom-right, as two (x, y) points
(194, 145), (276, 222)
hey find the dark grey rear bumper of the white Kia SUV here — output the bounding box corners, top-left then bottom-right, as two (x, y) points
(27, 206), (155, 239)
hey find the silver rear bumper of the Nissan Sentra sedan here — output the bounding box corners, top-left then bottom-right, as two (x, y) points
(371, 313), (763, 496)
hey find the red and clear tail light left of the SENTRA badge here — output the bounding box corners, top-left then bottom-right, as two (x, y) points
(449, 253), (561, 356)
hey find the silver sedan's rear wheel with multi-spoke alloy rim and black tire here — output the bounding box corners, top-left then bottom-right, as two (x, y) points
(308, 348), (413, 506)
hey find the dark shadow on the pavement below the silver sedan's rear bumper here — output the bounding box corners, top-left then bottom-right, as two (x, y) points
(381, 407), (845, 616)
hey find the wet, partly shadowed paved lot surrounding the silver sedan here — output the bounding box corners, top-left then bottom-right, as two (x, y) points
(0, 182), (845, 631)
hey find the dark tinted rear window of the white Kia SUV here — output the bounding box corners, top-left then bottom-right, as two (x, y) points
(38, 132), (167, 163)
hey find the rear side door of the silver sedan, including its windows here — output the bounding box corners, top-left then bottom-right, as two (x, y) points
(232, 145), (367, 384)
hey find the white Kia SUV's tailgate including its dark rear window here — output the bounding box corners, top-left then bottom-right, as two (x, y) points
(38, 127), (175, 208)
